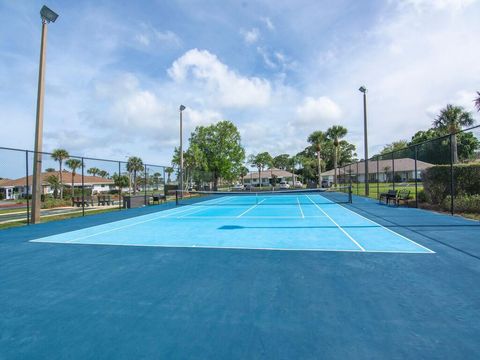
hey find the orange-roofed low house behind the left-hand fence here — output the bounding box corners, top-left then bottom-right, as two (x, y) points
(0, 170), (115, 200)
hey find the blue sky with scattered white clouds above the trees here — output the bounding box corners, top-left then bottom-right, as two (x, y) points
(0, 0), (480, 171)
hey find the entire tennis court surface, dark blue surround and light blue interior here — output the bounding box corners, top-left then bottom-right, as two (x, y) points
(0, 192), (480, 360)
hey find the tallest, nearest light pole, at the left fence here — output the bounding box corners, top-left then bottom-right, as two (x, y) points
(31, 5), (58, 224)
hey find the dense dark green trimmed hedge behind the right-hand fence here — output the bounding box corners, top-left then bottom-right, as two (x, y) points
(422, 164), (480, 204)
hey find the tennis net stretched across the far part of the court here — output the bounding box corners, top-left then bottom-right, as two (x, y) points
(176, 186), (352, 206)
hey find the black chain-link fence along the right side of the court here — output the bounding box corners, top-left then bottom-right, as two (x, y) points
(322, 126), (480, 219)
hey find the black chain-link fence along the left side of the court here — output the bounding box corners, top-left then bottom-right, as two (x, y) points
(0, 147), (172, 228)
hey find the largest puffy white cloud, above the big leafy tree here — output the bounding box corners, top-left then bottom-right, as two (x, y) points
(168, 49), (271, 108)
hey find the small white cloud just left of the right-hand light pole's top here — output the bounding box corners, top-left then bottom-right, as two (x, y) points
(296, 96), (342, 128)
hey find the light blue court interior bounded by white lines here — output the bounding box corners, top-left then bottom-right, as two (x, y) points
(31, 195), (433, 254)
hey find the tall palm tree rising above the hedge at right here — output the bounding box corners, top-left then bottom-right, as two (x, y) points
(433, 104), (475, 164)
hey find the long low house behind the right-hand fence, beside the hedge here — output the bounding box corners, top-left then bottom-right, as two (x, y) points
(321, 158), (433, 184)
